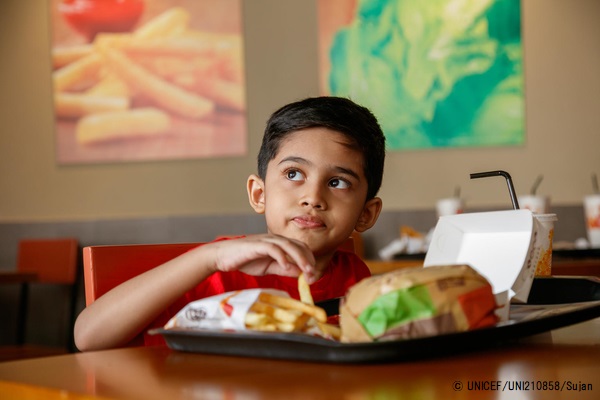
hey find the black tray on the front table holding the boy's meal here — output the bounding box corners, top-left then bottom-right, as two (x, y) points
(150, 278), (600, 363)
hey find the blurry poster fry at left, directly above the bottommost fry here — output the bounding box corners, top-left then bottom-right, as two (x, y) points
(54, 93), (129, 118)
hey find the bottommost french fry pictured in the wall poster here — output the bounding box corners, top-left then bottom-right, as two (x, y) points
(77, 108), (171, 144)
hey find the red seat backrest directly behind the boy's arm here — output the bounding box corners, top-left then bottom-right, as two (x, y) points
(83, 243), (201, 305)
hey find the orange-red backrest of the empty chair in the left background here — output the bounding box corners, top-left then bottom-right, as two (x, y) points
(17, 238), (79, 284)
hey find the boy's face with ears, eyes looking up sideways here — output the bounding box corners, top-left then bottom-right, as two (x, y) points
(248, 128), (381, 255)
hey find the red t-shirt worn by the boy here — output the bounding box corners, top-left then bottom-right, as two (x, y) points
(144, 242), (371, 346)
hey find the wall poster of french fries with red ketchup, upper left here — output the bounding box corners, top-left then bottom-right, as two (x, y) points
(50, 0), (247, 164)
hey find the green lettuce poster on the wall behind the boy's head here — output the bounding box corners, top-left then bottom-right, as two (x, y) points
(318, 0), (525, 150)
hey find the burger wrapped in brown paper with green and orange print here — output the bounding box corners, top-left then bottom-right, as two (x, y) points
(340, 265), (498, 342)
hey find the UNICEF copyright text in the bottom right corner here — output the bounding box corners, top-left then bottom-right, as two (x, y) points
(452, 380), (593, 392)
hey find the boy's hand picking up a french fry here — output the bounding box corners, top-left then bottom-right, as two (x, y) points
(212, 234), (321, 283)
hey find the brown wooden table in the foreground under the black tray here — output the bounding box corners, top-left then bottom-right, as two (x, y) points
(0, 318), (600, 400)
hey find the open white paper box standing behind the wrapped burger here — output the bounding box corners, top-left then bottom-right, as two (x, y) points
(424, 210), (539, 306)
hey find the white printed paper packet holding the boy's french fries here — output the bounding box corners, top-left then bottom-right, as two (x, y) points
(165, 289), (290, 331)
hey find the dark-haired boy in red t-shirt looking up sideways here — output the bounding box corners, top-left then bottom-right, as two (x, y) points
(75, 97), (385, 351)
